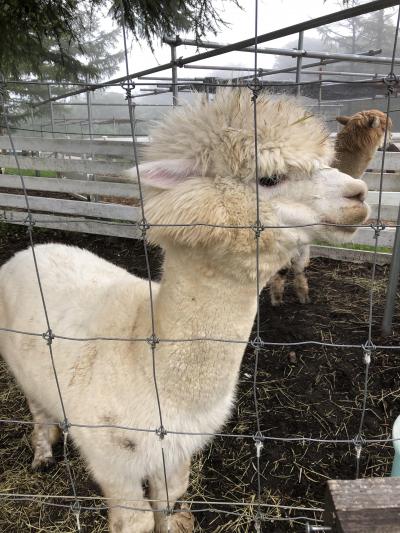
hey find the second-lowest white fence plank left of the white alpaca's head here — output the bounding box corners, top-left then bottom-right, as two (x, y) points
(0, 193), (140, 222)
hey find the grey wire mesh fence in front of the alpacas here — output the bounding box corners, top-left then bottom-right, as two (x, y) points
(0, 0), (400, 531)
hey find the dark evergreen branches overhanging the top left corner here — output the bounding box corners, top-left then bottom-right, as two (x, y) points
(0, 0), (238, 78)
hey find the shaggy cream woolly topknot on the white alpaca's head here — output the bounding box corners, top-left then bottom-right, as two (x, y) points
(143, 88), (333, 181)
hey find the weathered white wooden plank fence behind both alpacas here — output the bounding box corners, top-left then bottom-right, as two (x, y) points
(0, 134), (400, 252)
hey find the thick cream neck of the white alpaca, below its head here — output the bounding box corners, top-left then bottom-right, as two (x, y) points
(141, 248), (257, 406)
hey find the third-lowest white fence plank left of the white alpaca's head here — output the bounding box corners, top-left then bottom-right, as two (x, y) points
(0, 174), (139, 198)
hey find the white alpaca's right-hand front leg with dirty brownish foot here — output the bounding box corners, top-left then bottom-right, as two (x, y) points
(149, 461), (194, 533)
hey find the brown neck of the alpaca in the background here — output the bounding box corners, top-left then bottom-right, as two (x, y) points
(334, 134), (378, 178)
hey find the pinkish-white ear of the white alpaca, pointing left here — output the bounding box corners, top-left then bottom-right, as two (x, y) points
(124, 159), (196, 189)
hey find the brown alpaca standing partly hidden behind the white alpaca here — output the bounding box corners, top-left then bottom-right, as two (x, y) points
(270, 109), (392, 305)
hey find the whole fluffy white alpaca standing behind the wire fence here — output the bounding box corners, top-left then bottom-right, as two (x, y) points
(0, 89), (368, 533)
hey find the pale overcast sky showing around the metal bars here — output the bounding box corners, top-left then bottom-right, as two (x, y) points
(111, 0), (374, 83)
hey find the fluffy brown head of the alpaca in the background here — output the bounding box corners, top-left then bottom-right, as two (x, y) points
(336, 109), (392, 151)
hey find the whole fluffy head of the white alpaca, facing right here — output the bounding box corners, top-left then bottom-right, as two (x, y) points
(127, 88), (368, 282)
